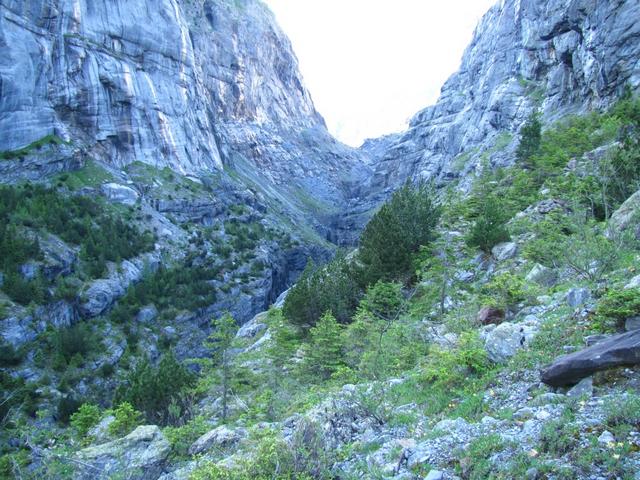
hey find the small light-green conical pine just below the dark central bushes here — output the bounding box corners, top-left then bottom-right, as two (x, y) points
(304, 312), (343, 380)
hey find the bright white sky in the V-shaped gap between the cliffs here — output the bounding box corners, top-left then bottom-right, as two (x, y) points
(265, 0), (496, 147)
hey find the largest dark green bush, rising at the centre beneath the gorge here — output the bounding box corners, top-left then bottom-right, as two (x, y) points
(358, 183), (441, 286)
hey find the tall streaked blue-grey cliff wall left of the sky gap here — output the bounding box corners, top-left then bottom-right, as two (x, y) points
(0, 0), (369, 240)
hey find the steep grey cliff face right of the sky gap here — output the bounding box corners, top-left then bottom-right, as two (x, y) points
(362, 0), (640, 193)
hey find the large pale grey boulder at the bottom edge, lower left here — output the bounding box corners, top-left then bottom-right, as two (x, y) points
(74, 425), (171, 480)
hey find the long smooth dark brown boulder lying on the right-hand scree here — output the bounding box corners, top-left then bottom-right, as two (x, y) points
(541, 330), (640, 387)
